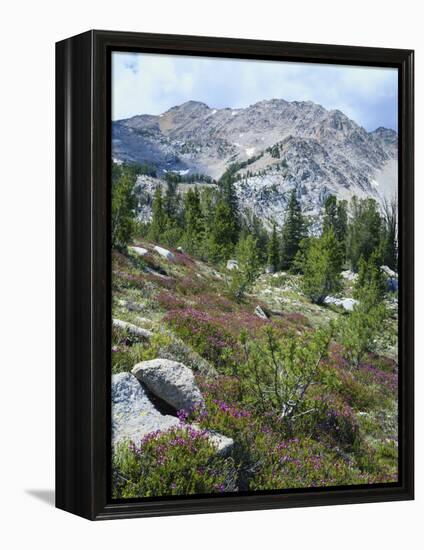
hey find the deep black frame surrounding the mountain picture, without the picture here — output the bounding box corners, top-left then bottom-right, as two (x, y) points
(56, 30), (414, 520)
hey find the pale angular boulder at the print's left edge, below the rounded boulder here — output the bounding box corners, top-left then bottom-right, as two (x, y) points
(112, 372), (180, 445)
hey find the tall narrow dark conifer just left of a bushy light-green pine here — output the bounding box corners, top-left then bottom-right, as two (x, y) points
(280, 190), (305, 269)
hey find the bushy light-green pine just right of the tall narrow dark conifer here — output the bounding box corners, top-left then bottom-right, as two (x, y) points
(302, 228), (342, 304)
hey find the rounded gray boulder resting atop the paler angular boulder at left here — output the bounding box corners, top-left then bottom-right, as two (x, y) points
(131, 359), (204, 411)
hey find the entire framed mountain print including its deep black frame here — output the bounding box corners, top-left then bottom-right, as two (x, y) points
(56, 31), (414, 519)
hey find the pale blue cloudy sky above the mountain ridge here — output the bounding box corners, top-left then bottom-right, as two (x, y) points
(112, 52), (397, 131)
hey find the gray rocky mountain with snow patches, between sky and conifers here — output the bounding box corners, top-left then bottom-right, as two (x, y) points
(112, 99), (398, 222)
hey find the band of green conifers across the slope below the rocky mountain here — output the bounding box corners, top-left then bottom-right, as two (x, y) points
(112, 160), (398, 303)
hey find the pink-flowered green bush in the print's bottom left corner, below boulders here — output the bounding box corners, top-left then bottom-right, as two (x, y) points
(113, 425), (235, 498)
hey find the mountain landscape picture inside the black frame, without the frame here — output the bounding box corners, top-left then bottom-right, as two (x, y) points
(110, 52), (398, 499)
